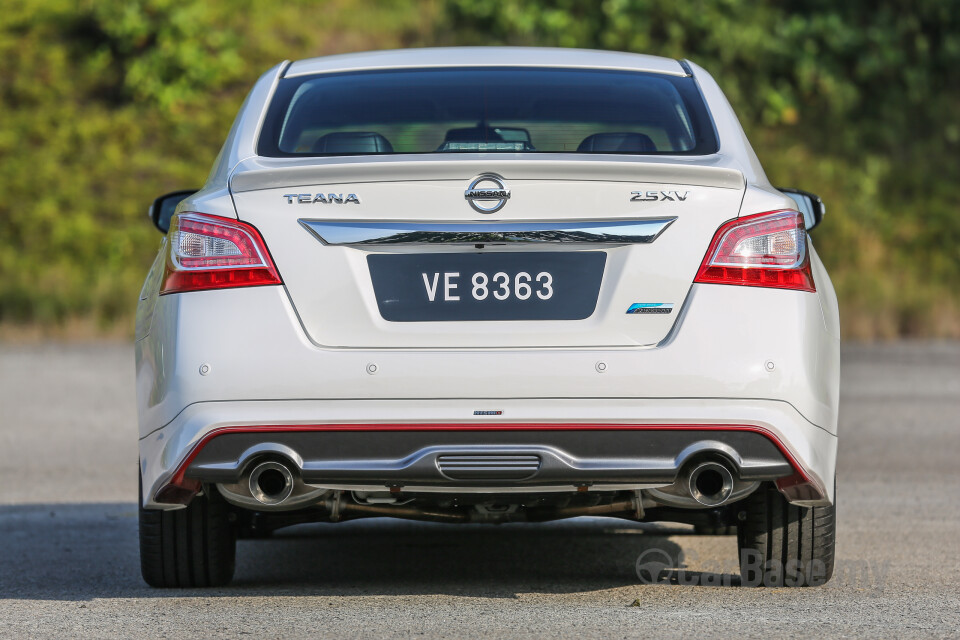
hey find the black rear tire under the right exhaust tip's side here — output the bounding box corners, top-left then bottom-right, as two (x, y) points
(737, 485), (837, 587)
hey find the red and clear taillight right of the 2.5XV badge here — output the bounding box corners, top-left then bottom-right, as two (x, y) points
(694, 211), (816, 291)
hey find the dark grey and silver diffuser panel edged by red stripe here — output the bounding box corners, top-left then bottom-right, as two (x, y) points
(181, 424), (793, 491)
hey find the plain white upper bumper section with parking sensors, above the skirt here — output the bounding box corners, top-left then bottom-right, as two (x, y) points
(136, 285), (840, 437)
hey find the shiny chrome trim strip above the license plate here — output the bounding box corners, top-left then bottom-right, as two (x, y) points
(298, 217), (677, 246)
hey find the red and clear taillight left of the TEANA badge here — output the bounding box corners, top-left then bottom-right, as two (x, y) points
(160, 213), (282, 295)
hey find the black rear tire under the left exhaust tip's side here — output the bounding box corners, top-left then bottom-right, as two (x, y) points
(140, 480), (237, 587)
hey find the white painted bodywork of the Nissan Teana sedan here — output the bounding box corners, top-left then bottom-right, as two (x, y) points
(136, 48), (839, 508)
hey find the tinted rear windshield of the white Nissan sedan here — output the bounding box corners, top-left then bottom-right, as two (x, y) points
(258, 67), (717, 157)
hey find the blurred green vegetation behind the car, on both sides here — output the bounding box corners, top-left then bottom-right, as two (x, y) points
(0, 0), (960, 339)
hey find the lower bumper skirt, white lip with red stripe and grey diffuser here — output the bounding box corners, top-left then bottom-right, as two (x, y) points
(141, 399), (836, 508)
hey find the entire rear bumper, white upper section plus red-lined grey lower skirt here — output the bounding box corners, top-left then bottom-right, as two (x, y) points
(137, 285), (839, 508)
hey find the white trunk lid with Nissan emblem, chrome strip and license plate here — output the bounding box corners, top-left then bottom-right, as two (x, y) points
(231, 156), (744, 349)
